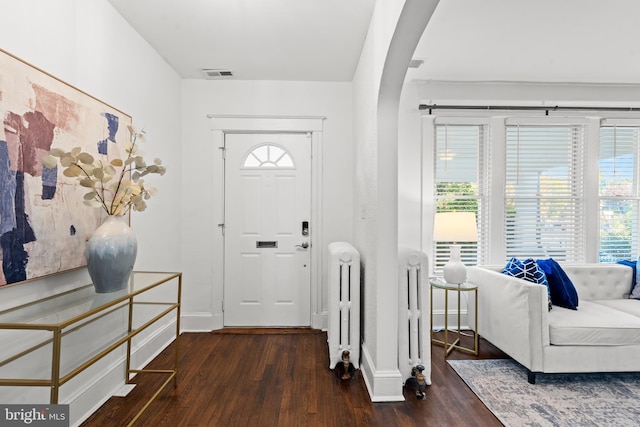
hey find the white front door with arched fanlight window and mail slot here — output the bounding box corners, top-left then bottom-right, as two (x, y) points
(224, 134), (311, 327)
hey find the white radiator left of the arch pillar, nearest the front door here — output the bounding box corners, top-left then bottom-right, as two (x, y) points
(327, 242), (360, 369)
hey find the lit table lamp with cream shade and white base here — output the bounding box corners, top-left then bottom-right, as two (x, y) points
(433, 212), (478, 285)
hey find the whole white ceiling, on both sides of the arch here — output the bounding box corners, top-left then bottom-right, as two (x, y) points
(109, 0), (640, 84)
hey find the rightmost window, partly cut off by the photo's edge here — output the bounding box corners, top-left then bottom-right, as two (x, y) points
(598, 125), (640, 262)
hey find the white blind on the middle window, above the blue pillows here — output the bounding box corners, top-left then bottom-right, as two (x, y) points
(504, 125), (585, 262)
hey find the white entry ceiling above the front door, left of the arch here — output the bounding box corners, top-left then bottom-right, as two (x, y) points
(109, 0), (375, 81)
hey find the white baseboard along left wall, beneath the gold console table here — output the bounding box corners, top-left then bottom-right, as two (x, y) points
(70, 319), (176, 426)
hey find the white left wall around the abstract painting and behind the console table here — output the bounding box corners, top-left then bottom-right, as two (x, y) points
(0, 0), (182, 424)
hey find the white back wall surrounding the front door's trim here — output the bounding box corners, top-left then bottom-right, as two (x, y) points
(182, 80), (354, 330)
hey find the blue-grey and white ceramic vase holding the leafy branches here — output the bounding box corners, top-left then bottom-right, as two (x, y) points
(86, 215), (138, 293)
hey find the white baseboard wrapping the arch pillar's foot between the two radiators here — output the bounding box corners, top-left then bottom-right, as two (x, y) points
(360, 343), (404, 402)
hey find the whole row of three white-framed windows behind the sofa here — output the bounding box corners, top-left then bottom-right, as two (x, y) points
(423, 114), (640, 273)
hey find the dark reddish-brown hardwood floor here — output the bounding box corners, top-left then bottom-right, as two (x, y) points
(82, 329), (506, 427)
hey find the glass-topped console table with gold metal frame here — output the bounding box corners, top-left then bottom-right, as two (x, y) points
(0, 271), (182, 425)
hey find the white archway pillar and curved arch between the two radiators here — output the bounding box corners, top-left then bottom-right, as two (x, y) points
(353, 0), (438, 401)
